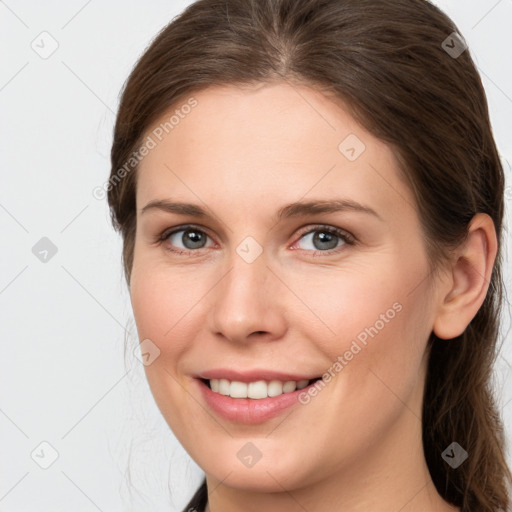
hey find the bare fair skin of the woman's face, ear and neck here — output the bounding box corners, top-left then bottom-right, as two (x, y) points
(130, 82), (496, 512)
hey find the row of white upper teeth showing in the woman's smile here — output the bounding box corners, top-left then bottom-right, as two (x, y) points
(209, 379), (309, 400)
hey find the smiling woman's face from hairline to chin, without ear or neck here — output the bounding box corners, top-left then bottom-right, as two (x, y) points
(131, 83), (442, 492)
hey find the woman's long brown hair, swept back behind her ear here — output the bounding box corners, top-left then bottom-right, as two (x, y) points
(108, 0), (512, 512)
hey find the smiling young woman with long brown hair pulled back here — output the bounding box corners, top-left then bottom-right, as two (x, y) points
(108, 0), (511, 512)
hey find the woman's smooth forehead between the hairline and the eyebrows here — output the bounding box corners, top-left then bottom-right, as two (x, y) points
(137, 83), (412, 220)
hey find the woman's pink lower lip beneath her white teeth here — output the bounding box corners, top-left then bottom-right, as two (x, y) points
(196, 379), (314, 424)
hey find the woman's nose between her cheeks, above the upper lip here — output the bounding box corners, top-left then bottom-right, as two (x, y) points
(209, 252), (287, 343)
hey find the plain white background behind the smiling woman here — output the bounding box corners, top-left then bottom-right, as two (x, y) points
(0, 0), (512, 512)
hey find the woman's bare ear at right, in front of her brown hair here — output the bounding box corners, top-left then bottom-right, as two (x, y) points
(433, 213), (498, 340)
